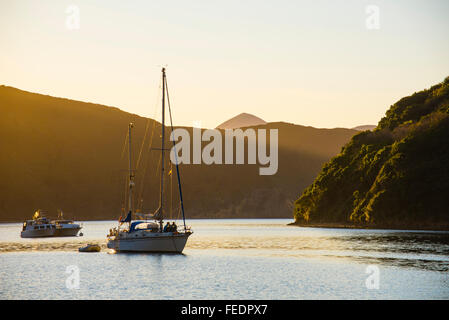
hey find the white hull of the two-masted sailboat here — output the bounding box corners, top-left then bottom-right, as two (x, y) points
(107, 233), (190, 253)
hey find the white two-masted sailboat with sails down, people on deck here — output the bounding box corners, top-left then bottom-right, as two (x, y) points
(107, 68), (193, 253)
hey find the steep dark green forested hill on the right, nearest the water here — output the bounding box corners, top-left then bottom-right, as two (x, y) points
(294, 77), (449, 229)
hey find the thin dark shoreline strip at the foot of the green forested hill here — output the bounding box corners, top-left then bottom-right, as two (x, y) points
(287, 221), (449, 231)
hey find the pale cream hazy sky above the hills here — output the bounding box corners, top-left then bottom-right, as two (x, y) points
(0, 0), (449, 128)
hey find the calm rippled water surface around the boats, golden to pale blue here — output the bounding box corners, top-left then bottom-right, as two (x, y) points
(0, 219), (449, 299)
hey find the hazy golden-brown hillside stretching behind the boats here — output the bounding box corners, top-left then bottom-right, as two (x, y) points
(0, 86), (357, 221)
